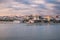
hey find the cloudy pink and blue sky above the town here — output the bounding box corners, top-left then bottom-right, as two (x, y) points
(0, 0), (60, 15)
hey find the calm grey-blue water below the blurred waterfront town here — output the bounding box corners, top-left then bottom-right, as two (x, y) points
(0, 23), (60, 40)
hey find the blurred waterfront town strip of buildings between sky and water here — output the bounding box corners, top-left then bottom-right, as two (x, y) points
(0, 15), (60, 23)
